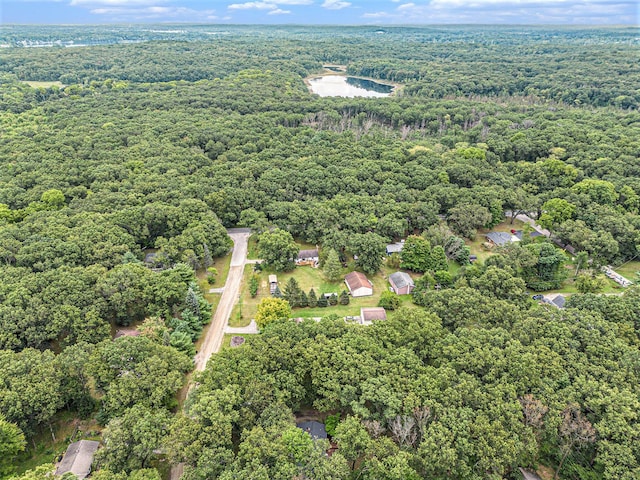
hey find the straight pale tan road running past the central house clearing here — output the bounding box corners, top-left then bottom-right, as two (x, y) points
(194, 228), (251, 372)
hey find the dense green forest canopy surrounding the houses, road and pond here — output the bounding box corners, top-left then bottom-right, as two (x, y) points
(0, 26), (640, 480)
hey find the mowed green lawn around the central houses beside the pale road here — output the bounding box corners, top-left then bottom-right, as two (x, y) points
(229, 265), (417, 327)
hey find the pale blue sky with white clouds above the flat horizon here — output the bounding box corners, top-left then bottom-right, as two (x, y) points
(0, 0), (640, 25)
